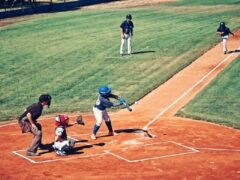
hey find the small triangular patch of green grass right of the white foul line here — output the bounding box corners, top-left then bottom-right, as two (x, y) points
(177, 57), (240, 129)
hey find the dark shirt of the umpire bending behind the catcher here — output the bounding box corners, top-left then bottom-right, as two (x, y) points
(19, 102), (43, 122)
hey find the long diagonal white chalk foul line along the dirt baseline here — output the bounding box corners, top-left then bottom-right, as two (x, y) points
(143, 46), (240, 130)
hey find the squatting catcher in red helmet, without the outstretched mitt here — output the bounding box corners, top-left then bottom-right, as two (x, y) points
(53, 114), (75, 156)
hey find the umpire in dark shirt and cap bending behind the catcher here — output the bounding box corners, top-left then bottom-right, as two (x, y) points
(18, 94), (52, 156)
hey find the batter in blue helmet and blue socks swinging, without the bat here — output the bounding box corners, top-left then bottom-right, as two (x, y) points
(91, 86), (122, 140)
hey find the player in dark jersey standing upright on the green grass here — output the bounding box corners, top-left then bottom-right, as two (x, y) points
(120, 14), (134, 55)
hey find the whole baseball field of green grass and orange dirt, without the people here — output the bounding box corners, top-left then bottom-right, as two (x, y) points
(0, 0), (240, 180)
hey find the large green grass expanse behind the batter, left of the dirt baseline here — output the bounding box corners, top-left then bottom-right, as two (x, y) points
(0, 1), (240, 120)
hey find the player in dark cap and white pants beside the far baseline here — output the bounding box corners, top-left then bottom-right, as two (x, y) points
(217, 22), (234, 54)
